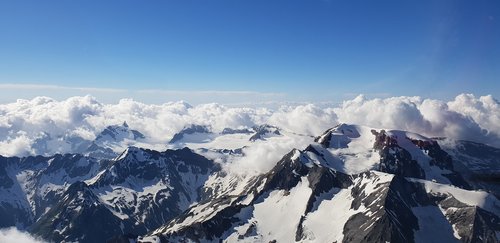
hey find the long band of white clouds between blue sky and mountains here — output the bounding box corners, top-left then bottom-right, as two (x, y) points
(0, 94), (500, 156)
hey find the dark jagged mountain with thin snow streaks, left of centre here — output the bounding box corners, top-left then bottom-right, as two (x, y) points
(30, 147), (218, 242)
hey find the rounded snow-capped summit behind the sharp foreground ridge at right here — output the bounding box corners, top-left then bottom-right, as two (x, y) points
(305, 124), (471, 189)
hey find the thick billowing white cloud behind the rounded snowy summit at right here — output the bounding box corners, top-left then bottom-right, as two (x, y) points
(334, 94), (500, 146)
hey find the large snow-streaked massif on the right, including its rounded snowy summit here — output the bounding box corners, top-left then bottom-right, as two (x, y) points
(141, 124), (500, 242)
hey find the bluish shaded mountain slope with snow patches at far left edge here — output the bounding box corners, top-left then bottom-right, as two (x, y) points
(0, 154), (99, 229)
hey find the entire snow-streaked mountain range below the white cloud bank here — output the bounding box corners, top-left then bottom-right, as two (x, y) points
(0, 124), (500, 242)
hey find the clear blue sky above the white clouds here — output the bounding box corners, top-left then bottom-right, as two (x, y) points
(0, 0), (500, 103)
